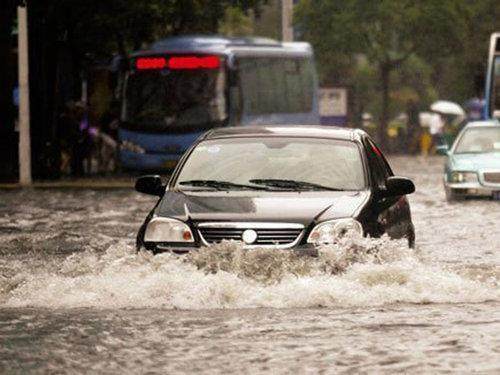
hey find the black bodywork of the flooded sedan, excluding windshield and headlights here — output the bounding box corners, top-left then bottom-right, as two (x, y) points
(136, 126), (415, 253)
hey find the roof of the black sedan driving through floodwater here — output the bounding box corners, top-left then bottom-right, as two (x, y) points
(202, 125), (366, 141)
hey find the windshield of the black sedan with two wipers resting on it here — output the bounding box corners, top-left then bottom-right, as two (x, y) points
(175, 137), (365, 191)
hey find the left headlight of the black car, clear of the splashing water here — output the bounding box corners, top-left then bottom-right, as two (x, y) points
(144, 217), (194, 242)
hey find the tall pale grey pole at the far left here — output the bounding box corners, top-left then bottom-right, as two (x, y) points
(17, 4), (32, 186)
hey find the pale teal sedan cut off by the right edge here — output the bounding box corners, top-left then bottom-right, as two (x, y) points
(438, 121), (500, 201)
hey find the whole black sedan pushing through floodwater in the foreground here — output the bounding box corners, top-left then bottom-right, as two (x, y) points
(136, 126), (415, 253)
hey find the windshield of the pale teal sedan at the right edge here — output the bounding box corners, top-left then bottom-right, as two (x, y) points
(455, 126), (500, 154)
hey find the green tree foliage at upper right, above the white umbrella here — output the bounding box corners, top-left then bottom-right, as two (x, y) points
(295, 0), (500, 137)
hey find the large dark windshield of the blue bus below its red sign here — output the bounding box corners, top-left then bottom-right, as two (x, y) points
(123, 69), (228, 132)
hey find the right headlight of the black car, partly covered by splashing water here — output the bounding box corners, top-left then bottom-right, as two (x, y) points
(307, 219), (363, 245)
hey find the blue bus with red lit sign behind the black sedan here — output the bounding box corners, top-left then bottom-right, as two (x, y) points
(119, 36), (319, 170)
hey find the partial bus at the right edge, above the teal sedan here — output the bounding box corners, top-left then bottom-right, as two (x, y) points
(484, 33), (500, 119)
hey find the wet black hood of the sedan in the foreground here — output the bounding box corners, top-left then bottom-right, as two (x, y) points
(155, 191), (370, 226)
